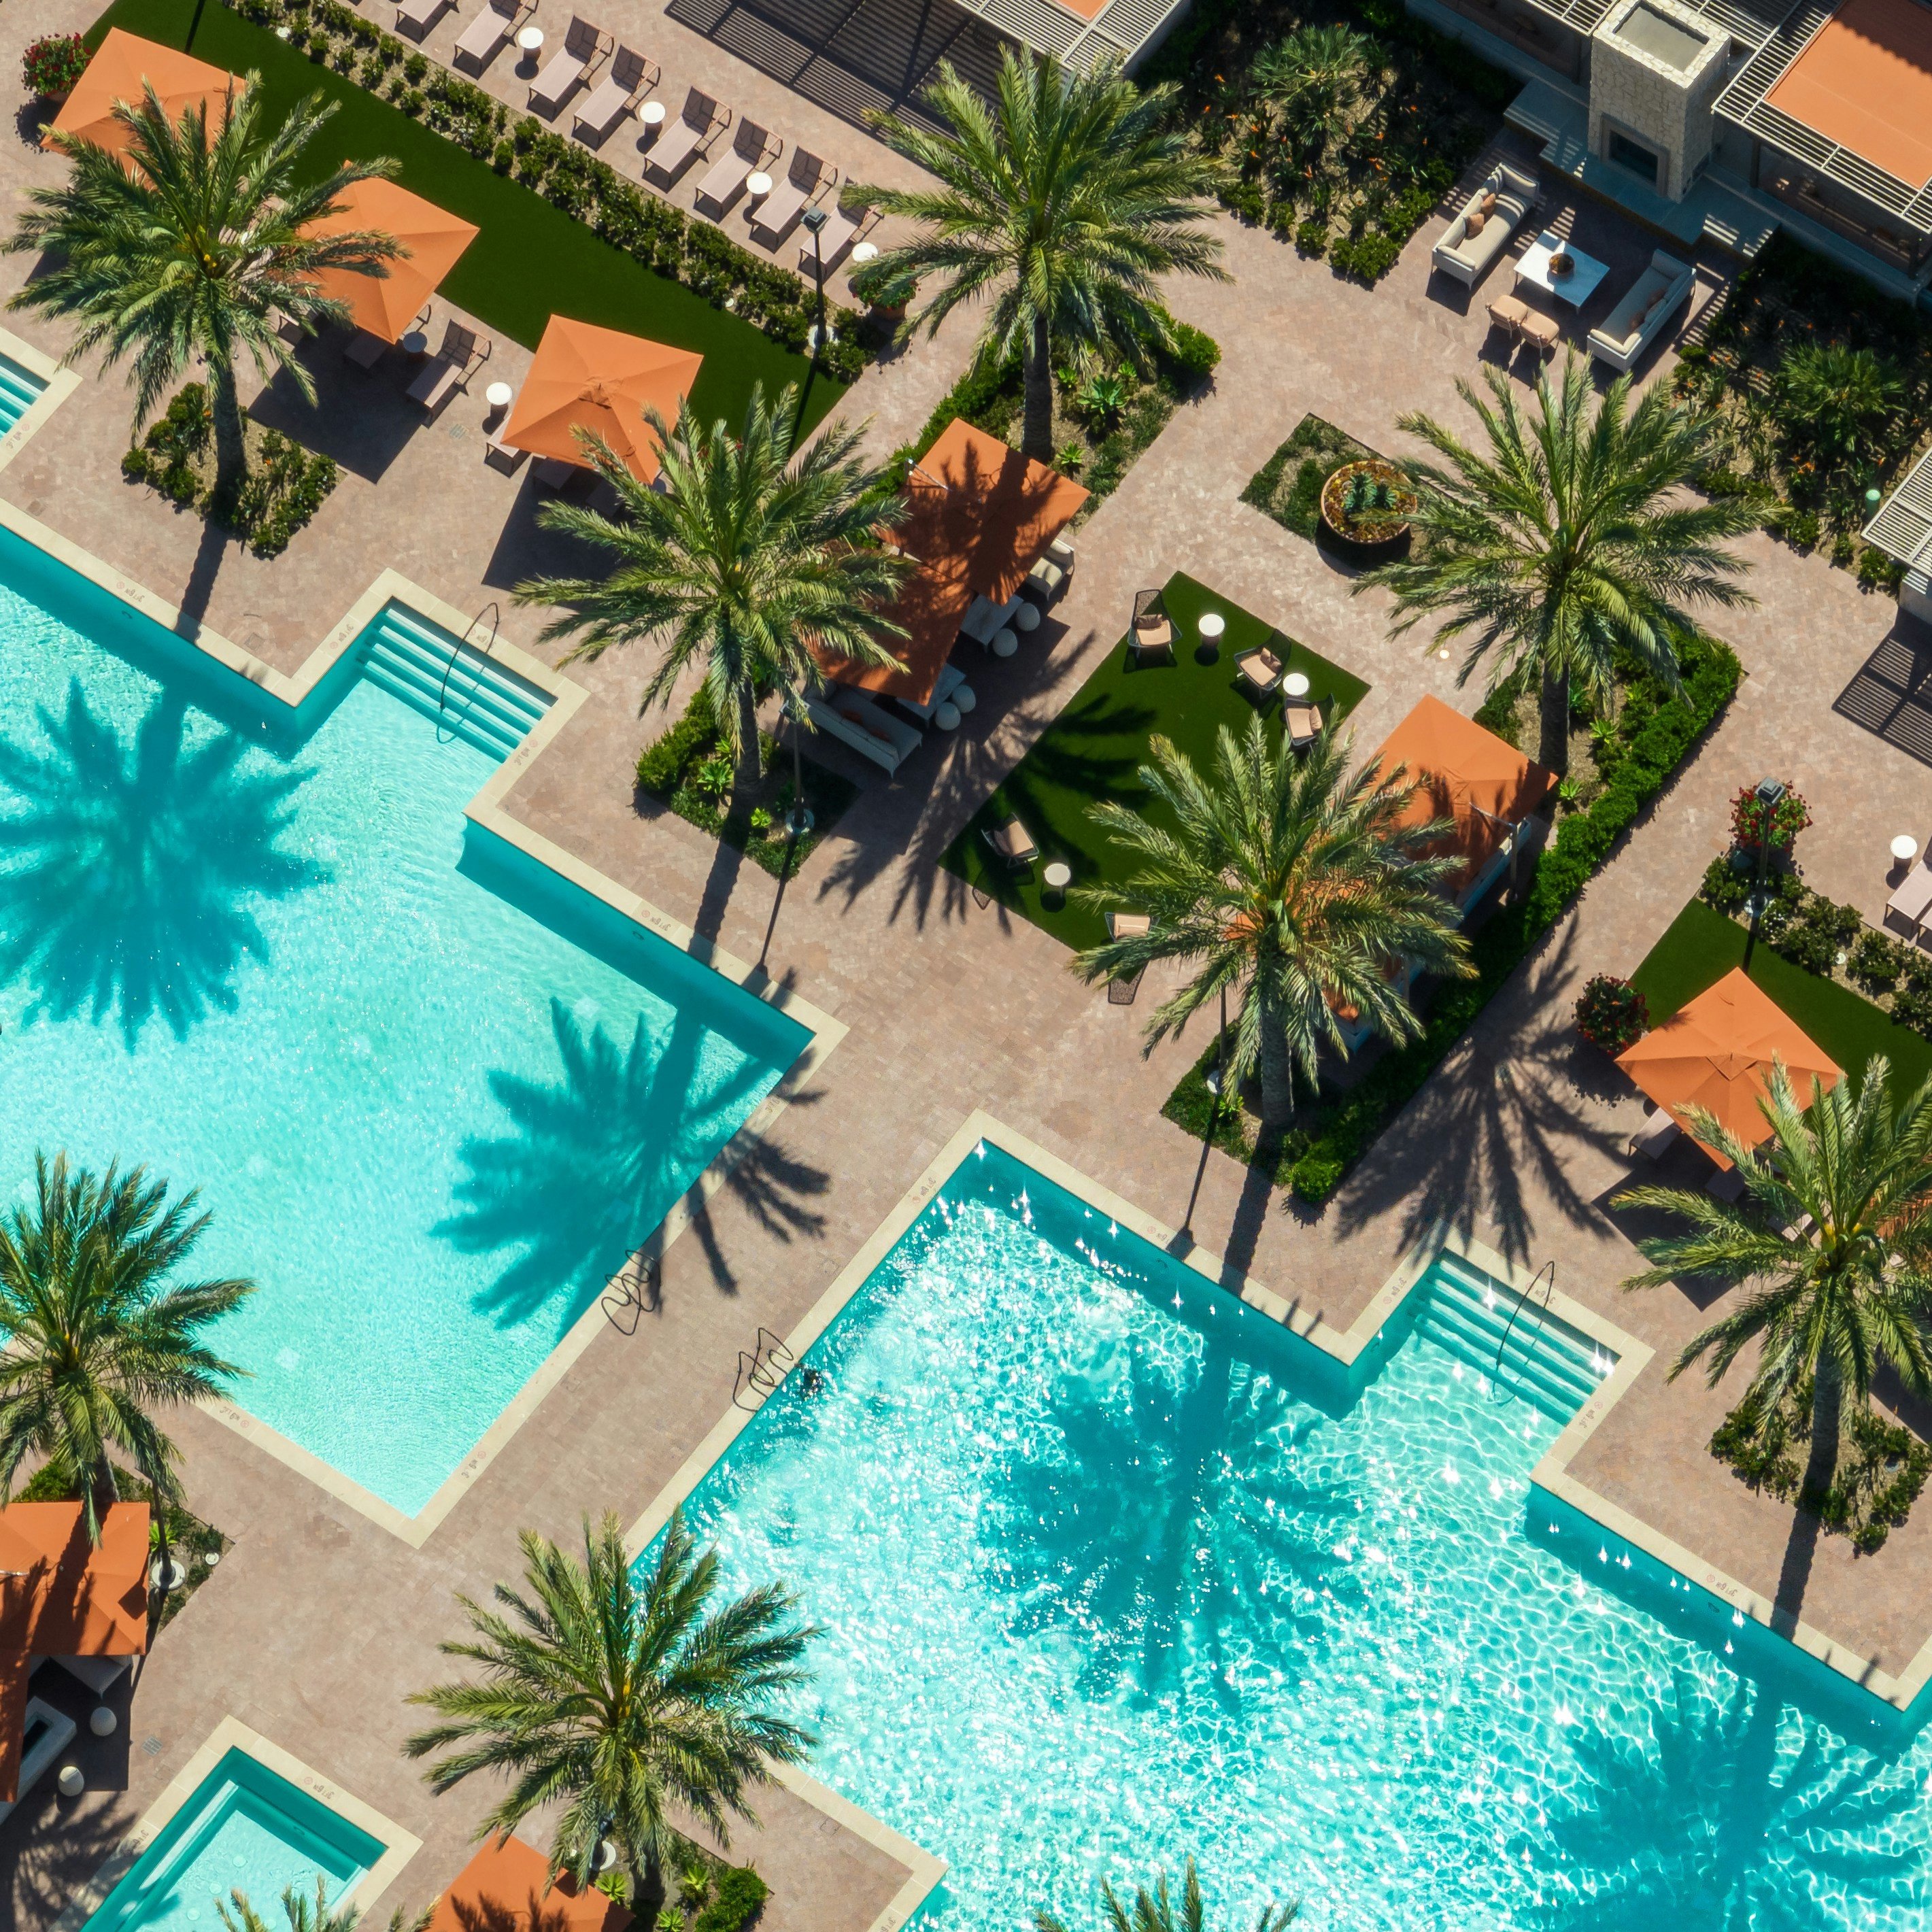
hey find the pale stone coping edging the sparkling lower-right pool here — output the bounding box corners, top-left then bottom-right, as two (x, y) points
(628, 1111), (1932, 1714)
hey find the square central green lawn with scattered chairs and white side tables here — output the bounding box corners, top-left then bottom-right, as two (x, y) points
(943, 576), (1368, 949)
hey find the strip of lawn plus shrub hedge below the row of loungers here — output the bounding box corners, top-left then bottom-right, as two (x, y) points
(89, 0), (862, 427)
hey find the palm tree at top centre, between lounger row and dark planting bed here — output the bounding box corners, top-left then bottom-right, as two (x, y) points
(854, 46), (1227, 462)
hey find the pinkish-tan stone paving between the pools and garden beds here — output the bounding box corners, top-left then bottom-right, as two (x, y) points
(0, 0), (1932, 1932)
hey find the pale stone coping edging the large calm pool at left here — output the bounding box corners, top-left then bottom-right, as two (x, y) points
(0, 328), (846, 1549)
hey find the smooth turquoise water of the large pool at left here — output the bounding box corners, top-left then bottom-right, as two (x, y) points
(0, 537), (808, 1513)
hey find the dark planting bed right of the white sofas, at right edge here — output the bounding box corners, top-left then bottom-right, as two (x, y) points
(1673, 236), (1932, 590)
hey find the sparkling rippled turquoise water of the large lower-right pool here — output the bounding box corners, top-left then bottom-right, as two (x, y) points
(660, 1151), (1932, 1932)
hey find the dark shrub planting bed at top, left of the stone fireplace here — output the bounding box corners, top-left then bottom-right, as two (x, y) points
(1140, 0), (1523, 282)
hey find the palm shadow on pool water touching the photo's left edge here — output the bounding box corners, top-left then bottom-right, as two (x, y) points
(0, 678), (328, 1051)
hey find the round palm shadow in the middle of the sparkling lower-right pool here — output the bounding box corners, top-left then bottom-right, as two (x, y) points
(989, 1331), (1358, 1708)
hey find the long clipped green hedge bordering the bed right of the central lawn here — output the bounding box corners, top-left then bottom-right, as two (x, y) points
(1161, 639), (1743, 1208)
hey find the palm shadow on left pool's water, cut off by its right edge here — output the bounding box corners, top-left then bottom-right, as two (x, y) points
(433, 999), (823, 1327)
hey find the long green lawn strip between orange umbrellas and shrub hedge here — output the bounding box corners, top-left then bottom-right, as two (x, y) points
(89, 0), (845, 427)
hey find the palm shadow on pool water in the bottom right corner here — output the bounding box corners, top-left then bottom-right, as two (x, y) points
(1516, 1675), (1928, 1932)
